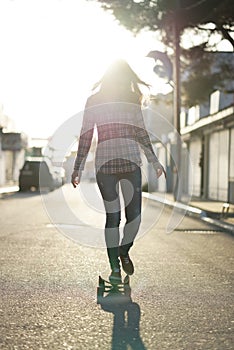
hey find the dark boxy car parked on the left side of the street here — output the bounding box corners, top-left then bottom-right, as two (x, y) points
(19, 157), (65, 191)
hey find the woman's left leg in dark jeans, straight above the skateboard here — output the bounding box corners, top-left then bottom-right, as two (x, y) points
(96, 172), (121, 270)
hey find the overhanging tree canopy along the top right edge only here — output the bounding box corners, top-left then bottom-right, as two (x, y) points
(93, 0), (234, 48)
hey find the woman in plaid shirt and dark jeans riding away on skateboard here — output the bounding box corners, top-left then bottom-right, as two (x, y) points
(71, 60), (166, 284)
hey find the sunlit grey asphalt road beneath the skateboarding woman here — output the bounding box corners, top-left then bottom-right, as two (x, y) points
(0, 184), (234, 350)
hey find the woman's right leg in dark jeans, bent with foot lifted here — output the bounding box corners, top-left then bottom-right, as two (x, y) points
(120, 168), (142, 255)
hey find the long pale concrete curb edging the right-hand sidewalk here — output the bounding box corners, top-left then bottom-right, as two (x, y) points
(142, 192), (234, 235)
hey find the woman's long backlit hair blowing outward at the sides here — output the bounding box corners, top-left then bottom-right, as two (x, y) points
(93, 60), (149, 103)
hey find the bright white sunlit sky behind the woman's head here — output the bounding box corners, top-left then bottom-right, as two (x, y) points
(0, 0), (232, 138)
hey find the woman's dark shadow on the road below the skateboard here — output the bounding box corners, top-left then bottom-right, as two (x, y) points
(99, 292), (146, 350)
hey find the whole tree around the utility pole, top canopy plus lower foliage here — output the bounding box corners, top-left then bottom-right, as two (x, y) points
(89, 0), (234, 106)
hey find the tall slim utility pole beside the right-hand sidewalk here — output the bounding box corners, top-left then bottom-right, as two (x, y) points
(173, 0), (182, 201)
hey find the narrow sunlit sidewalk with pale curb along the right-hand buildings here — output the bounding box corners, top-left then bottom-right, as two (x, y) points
(143, 192), (234, 234)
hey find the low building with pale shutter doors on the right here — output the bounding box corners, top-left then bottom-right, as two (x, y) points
(181, 91), (234, 203)
